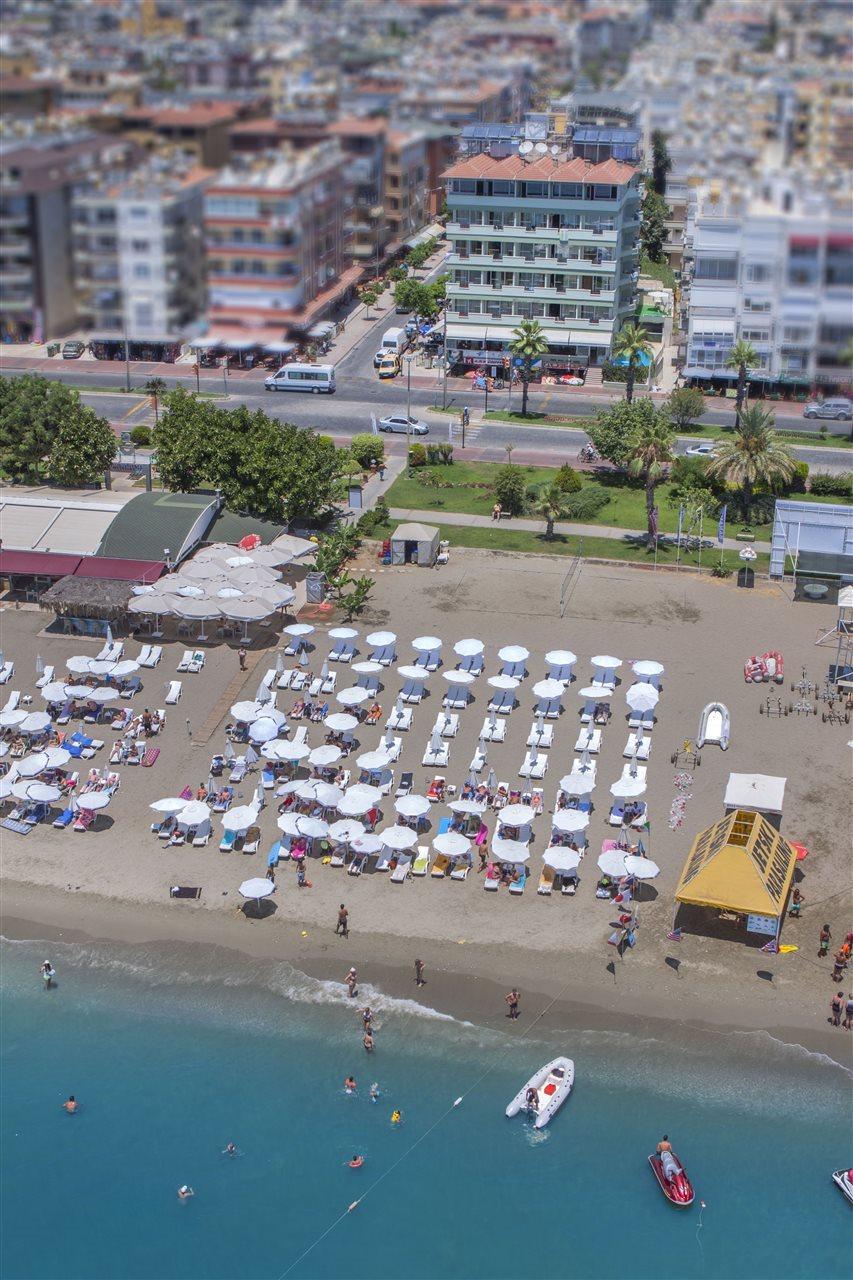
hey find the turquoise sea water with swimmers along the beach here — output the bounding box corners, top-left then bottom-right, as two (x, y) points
(0, 943), (853, 1280)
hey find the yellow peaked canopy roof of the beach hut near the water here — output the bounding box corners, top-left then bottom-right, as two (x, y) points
(675, 809), (797, 916)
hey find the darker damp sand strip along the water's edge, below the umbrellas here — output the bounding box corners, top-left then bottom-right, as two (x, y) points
(0, 881), (853, 1071)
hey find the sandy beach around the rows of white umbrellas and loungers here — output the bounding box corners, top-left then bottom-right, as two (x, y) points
(1, 550), (852, 1061)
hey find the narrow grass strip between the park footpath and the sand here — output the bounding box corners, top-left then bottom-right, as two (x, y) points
(373, 522), (770, 573)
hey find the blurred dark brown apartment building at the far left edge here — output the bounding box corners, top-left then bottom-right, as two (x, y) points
(0, 133), (134, 342)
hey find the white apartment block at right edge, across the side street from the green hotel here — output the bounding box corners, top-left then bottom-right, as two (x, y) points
(684, 174), (853, 388)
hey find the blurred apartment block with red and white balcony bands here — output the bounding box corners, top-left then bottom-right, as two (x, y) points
(205, 142), (360, 333)
